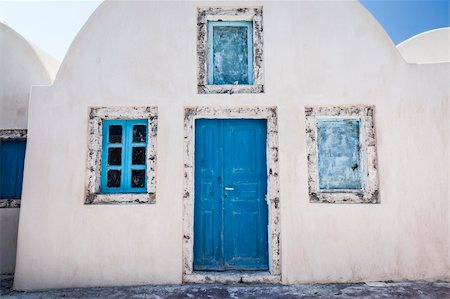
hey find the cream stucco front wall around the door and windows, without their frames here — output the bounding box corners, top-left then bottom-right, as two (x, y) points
(15, 1), (449, 289)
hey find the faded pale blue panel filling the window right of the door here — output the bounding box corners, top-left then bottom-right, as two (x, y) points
(317, 119), (361, 190)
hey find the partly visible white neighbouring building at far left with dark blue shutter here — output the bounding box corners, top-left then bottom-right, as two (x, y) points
(0, 23), (59, 274)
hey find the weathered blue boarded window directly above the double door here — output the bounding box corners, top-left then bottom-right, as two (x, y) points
(208, 21), (253, 85)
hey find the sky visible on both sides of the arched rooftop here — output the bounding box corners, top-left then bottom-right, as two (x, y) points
(0, 0), (450, 60)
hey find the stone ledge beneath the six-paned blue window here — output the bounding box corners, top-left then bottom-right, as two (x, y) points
(85, 193), (156, 205)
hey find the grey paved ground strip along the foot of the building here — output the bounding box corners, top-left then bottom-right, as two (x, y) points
(0, 276), (450, 299)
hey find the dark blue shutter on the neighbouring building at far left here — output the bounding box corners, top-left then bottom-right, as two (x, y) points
(0, 140), (26, 199)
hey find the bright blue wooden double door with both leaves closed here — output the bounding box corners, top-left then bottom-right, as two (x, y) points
(194, 119), (268, 271)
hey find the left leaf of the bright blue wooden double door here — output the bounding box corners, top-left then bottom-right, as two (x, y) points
(194, 120), (223, 270)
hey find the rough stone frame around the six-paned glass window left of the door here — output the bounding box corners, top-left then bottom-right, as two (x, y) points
(85, 107), (158, 204)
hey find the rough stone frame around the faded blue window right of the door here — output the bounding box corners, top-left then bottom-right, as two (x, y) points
(305, 105), (380, 204)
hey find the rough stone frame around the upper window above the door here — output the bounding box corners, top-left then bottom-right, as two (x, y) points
(197, 6), (264, 94)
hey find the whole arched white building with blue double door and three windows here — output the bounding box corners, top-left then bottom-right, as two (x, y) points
(4, 1), (449, 290)
